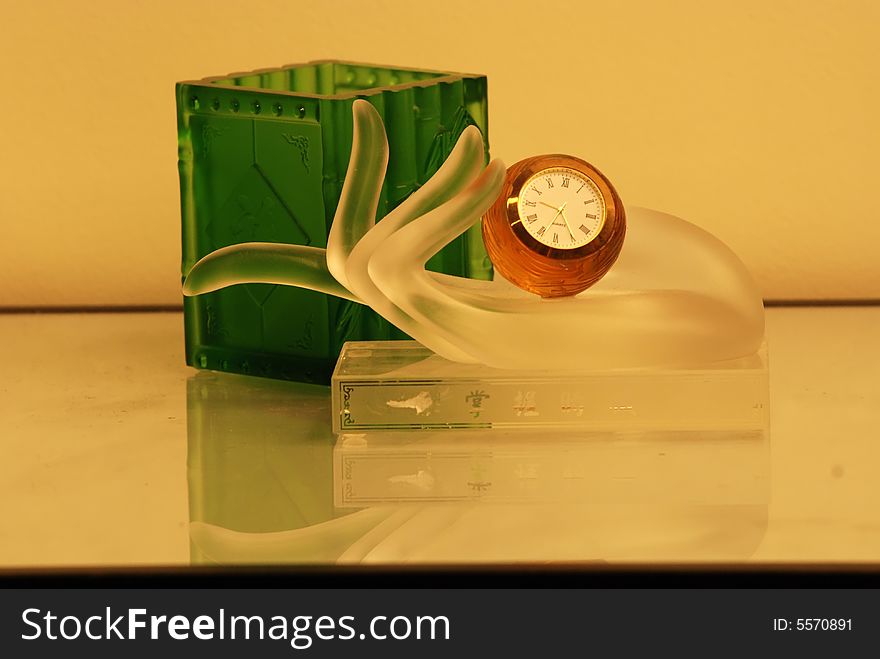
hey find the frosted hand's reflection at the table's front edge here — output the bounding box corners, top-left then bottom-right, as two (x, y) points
(190, 502), (767, 565)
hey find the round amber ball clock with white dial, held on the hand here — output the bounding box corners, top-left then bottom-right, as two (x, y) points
(483, 154), (626, 298)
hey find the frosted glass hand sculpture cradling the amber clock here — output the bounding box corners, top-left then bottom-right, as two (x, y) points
(184, 101), (764, 369)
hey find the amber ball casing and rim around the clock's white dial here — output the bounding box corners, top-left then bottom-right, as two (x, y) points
(483, 154), (626, 297)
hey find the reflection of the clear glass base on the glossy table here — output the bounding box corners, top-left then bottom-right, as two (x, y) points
(333, 431), (769, 508)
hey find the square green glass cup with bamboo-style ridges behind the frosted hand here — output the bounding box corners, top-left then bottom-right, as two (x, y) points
(177, 61), (491, 383)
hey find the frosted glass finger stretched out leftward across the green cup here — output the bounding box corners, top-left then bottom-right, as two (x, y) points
(183, 243), (360, 302)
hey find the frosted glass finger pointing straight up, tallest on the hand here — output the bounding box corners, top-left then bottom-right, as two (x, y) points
(327, 99), (388, 290)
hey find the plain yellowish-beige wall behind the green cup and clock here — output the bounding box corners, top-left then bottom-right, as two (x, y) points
(0, 0), (880, 307)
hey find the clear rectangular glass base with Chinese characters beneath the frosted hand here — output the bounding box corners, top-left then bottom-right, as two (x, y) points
(331, 341), (769, 433)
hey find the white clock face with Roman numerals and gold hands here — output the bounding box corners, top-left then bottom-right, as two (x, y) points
(517, 167), (605, 249)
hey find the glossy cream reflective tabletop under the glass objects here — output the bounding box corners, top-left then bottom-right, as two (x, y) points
(0, 307), (880, 569)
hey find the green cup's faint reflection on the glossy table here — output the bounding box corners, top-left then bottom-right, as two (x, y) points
(186, 373), (336, 563)
